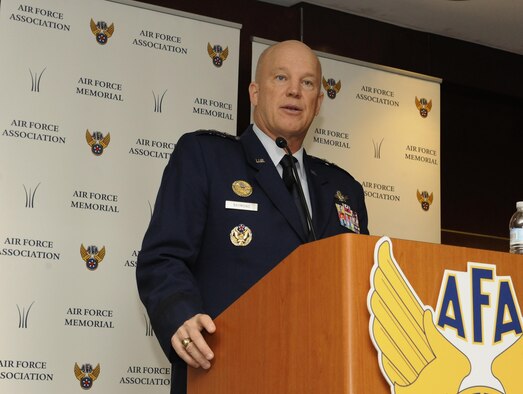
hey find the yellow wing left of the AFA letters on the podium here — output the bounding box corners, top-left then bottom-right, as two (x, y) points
(368, 237), (470, 394)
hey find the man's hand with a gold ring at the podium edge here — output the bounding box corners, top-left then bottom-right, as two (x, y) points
(171, 313), (216, 369)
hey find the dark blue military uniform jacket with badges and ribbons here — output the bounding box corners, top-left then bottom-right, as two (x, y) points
(136, 126), (368, 393)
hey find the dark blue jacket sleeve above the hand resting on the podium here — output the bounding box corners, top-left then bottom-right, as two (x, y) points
(136, 134), (208, 361)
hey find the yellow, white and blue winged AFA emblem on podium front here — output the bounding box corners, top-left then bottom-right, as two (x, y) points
(367, 237), (523, 394)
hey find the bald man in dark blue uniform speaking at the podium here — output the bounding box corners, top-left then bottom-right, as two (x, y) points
(136, 41), (368, 393)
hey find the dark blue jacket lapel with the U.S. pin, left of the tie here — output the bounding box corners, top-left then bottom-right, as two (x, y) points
(240, 126), (306, 242)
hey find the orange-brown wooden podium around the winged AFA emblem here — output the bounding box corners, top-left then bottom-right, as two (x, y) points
(188, 234), (523, 394)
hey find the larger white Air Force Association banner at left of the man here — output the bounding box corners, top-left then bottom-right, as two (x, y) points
(0, 0), (240, 394)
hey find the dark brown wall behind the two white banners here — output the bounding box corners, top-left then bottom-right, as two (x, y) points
(136, 0), (523, 251)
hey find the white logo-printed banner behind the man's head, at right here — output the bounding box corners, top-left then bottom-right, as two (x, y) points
(253, 38), (441, 243)
